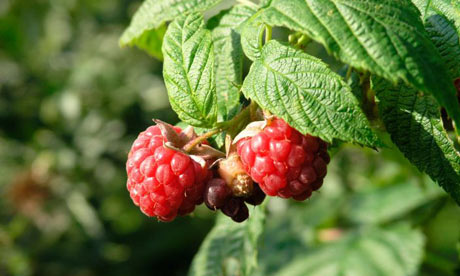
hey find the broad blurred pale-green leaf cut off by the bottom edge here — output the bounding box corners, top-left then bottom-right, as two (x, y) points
(269, 224), (424, 276)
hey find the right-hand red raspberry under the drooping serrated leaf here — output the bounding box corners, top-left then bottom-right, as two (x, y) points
(237, 118), (330, 200)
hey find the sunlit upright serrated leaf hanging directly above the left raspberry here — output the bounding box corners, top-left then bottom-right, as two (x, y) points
(163, 13), (216, 127)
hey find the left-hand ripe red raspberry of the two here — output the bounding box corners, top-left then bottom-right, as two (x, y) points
(126, 125), (211, 221)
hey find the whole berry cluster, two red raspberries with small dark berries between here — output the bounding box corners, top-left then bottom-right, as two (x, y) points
(126, 118), (330, 222)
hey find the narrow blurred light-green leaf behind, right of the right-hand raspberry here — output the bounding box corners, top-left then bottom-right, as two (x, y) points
(343, 179), (444, 224)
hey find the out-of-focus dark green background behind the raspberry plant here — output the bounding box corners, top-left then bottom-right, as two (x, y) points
(0, 0), (460, 276)
